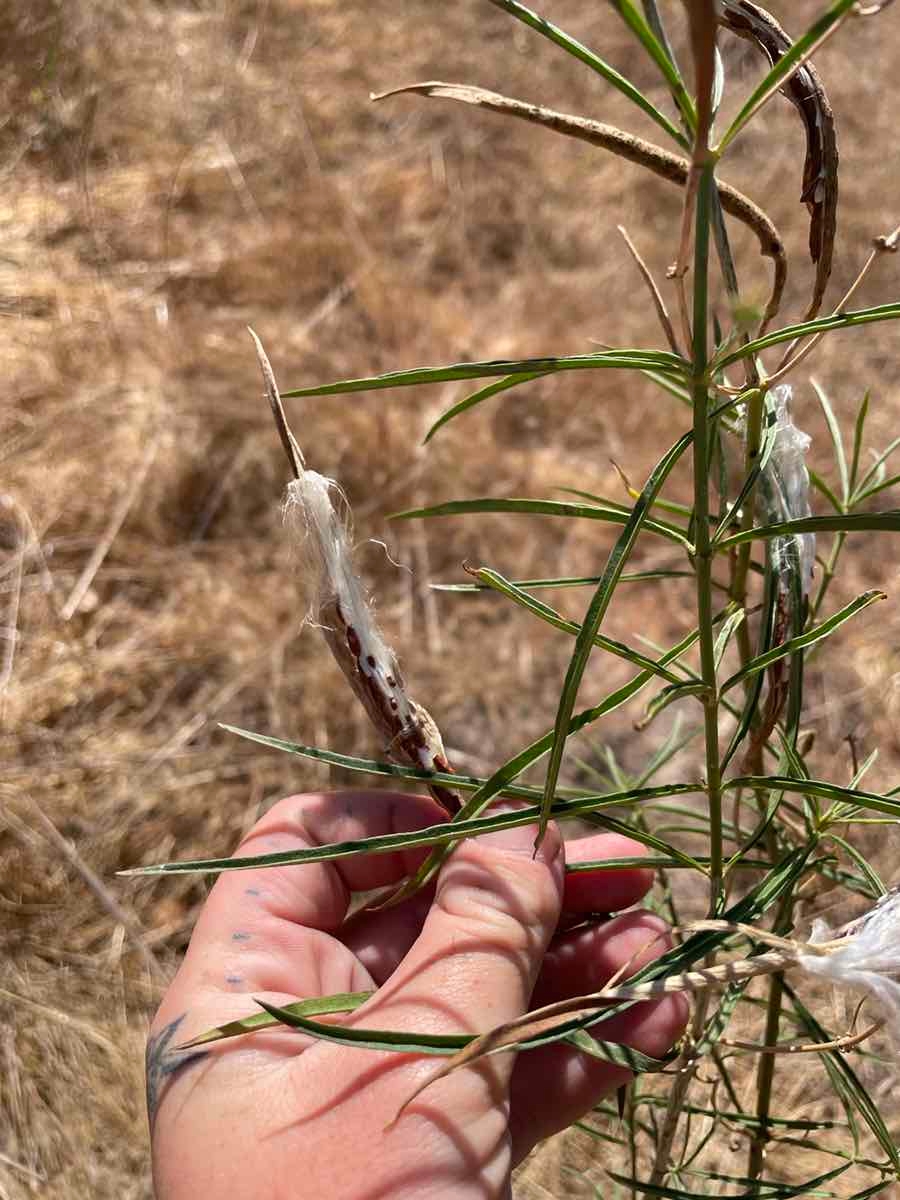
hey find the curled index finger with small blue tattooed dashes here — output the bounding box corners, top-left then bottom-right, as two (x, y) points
(158, 792), (445, 1012)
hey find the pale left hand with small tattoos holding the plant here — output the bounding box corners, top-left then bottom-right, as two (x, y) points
(148, 792), (686, 1200)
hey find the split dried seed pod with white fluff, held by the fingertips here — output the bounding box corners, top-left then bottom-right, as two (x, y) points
(250, 330), (461, 814)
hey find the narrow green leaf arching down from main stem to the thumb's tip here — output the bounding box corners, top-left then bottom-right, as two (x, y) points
(539, 433), (694, 839)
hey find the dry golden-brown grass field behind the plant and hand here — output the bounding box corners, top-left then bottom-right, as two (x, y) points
(0, 0), (900, 1200)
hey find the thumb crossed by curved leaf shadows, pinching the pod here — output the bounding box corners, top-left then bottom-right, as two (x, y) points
(360, 824), (564, 1036)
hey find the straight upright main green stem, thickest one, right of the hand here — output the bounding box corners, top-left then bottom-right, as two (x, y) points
(691, 158), (722, 913)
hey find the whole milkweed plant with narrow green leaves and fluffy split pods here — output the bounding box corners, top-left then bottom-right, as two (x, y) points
(132, 0), (900, 1200)
